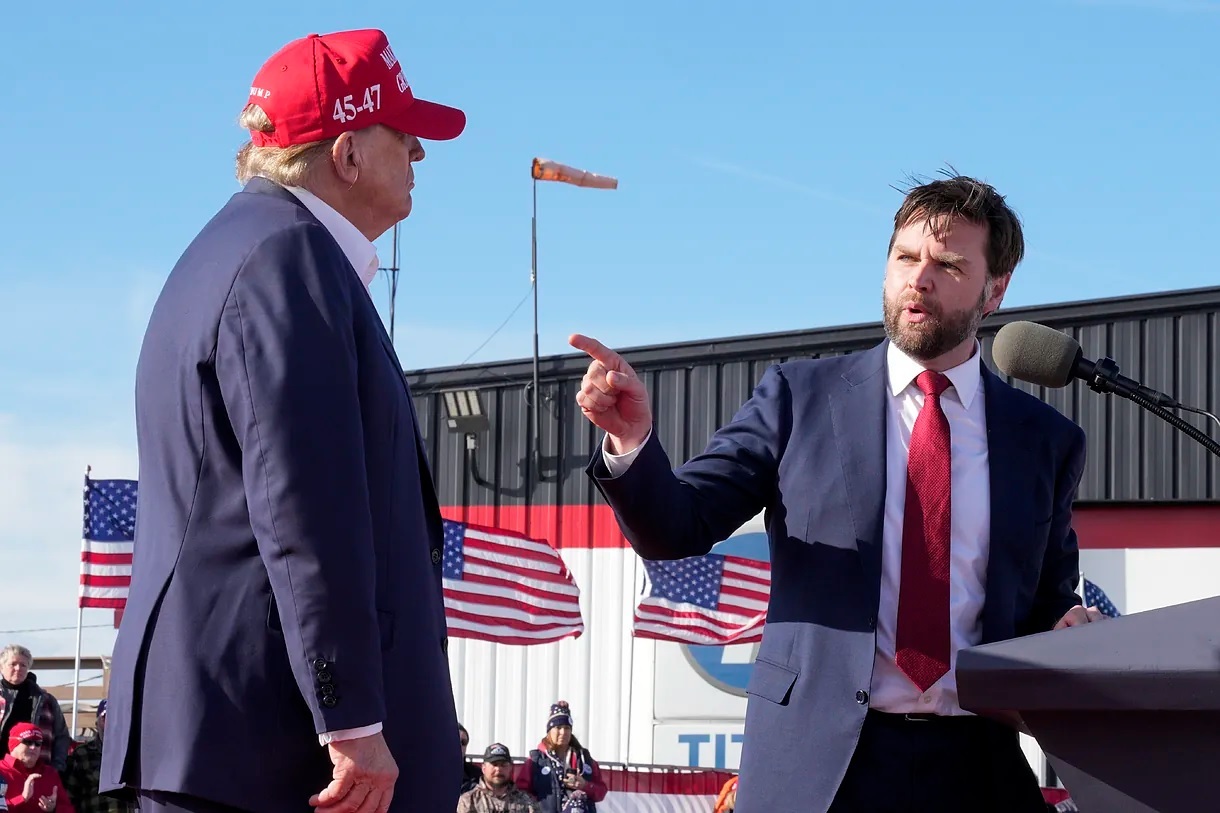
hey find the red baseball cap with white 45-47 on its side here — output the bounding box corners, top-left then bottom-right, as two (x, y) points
(248, 28), (466, 146)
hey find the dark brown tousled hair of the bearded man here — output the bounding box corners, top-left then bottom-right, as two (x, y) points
(887, 167), (1025, 280)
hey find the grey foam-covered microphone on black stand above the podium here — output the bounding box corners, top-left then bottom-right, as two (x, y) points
(992, 322), (1183, 409)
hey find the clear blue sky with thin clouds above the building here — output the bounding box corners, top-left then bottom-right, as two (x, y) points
(0, 0), (1220, 654)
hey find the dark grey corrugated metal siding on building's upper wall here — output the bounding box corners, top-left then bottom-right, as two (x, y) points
(409, 288), (1220, 502)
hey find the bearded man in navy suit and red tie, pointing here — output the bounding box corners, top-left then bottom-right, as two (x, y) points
(571, 176), (1100, 813)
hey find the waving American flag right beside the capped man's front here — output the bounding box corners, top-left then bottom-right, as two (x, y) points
(442, 520), (584, 646)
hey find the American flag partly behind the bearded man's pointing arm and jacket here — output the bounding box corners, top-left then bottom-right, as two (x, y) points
(634, 553), (771, 646)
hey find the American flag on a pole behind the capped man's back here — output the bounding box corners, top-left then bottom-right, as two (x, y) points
(79, 477), (138, 609)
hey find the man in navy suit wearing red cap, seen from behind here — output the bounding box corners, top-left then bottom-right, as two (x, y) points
(102, 31), (466, 813)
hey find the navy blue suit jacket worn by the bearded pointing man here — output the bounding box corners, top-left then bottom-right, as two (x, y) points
(589, 343), (1085, 813)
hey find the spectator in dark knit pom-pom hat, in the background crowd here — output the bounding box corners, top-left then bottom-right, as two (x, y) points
(517, 701), (606, 813)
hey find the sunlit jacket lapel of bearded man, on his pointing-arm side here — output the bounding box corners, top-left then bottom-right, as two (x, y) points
(830, 343), (888, 608)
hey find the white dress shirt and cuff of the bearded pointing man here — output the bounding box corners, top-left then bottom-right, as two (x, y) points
(601, 343), (991, 715)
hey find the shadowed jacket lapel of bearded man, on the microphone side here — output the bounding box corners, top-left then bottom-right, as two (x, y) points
(982, 367), (1033, 642)
